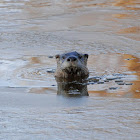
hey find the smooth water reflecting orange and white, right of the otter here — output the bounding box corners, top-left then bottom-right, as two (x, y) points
(88, 54), (140, 98)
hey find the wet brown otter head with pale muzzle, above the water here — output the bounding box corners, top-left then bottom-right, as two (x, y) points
(55, 52), (89, 78)
